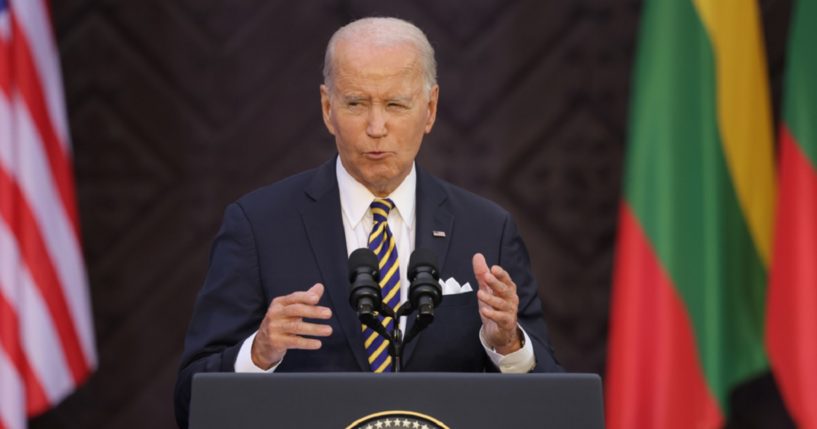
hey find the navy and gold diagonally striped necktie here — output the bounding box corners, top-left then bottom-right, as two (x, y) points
(363, 198), (400, 372)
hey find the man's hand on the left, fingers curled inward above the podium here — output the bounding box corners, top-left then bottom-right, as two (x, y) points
(252, 283), (332, 370)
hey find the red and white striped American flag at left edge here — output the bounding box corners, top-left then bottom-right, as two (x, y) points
(0, 0), (96, 429)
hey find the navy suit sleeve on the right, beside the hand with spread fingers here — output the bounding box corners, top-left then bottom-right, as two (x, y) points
(499, 215), (564, 372)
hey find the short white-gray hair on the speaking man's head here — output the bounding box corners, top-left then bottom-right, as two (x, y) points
(323, 17), (437, 92)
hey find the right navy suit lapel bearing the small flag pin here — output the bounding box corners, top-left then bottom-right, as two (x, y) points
(403, 166), (454, 365)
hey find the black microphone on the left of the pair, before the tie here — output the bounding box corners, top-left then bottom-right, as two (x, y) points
(349, 248), (383, 317)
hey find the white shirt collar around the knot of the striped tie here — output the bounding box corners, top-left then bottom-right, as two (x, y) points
(335, 157), (417, 228)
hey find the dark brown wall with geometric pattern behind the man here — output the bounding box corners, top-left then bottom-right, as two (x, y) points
(32, 0), (790, 429)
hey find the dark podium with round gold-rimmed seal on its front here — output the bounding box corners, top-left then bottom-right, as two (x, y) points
(190, 372), (604, 429)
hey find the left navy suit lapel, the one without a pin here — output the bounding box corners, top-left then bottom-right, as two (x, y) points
(301, 158), (369, 371)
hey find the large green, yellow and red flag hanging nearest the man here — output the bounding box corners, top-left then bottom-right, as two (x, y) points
(605, 0), (776, 429)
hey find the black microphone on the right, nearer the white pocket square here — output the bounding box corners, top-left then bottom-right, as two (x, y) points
(408, 249), (443, 322)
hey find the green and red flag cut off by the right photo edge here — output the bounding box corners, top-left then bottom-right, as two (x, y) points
(766, 0), (817, 428)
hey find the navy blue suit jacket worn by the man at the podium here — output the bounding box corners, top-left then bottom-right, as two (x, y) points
(175, 159), (561, 427)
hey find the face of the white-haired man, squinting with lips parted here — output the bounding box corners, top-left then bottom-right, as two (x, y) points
(321, 41), (439, 196)
